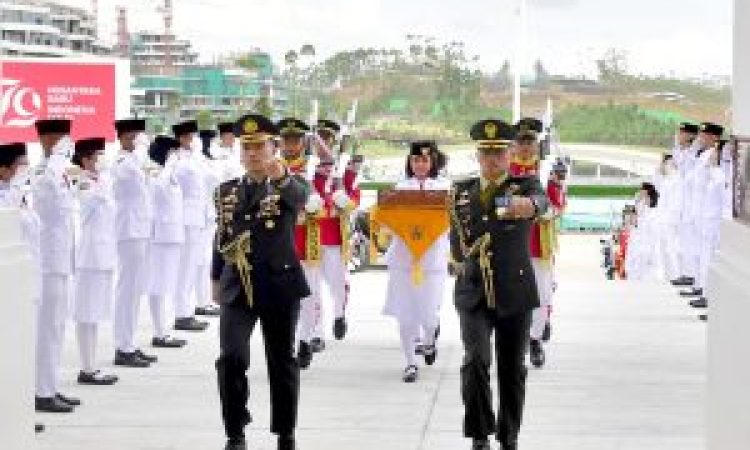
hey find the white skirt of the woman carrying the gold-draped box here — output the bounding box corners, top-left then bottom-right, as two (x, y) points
(383, 268), (448, 327)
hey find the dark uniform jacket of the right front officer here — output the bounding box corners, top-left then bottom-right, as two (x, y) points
(450, 177), (548, 316)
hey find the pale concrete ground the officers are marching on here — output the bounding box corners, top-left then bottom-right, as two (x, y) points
(37, 236), (706, 450)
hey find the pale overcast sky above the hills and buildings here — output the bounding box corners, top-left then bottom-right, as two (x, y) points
(58, 0), (732, 76)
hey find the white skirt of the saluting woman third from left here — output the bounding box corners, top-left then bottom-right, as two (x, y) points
(73, 269), (115, 323)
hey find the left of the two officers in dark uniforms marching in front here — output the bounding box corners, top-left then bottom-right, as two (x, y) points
(211, 115), (310, 450)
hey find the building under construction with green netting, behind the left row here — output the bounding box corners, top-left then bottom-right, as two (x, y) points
(130, 33), (286, 128)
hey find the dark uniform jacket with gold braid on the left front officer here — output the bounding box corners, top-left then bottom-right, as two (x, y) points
(211, 175), (310, 306)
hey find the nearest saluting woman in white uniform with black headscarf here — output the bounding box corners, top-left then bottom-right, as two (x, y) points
(148, 136), (187, 348)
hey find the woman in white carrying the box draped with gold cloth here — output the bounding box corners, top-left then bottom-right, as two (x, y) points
(383, 141), (450, 383)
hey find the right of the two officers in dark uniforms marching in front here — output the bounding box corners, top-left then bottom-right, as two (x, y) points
(449, 120), (547, 450)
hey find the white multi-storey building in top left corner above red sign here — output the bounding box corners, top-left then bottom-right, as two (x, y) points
(0, 0), (111, 57)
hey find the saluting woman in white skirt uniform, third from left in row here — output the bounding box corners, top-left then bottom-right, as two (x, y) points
(73, 138), (118, 385)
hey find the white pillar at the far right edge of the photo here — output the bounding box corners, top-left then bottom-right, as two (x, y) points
(706, 0), (750, 450)
